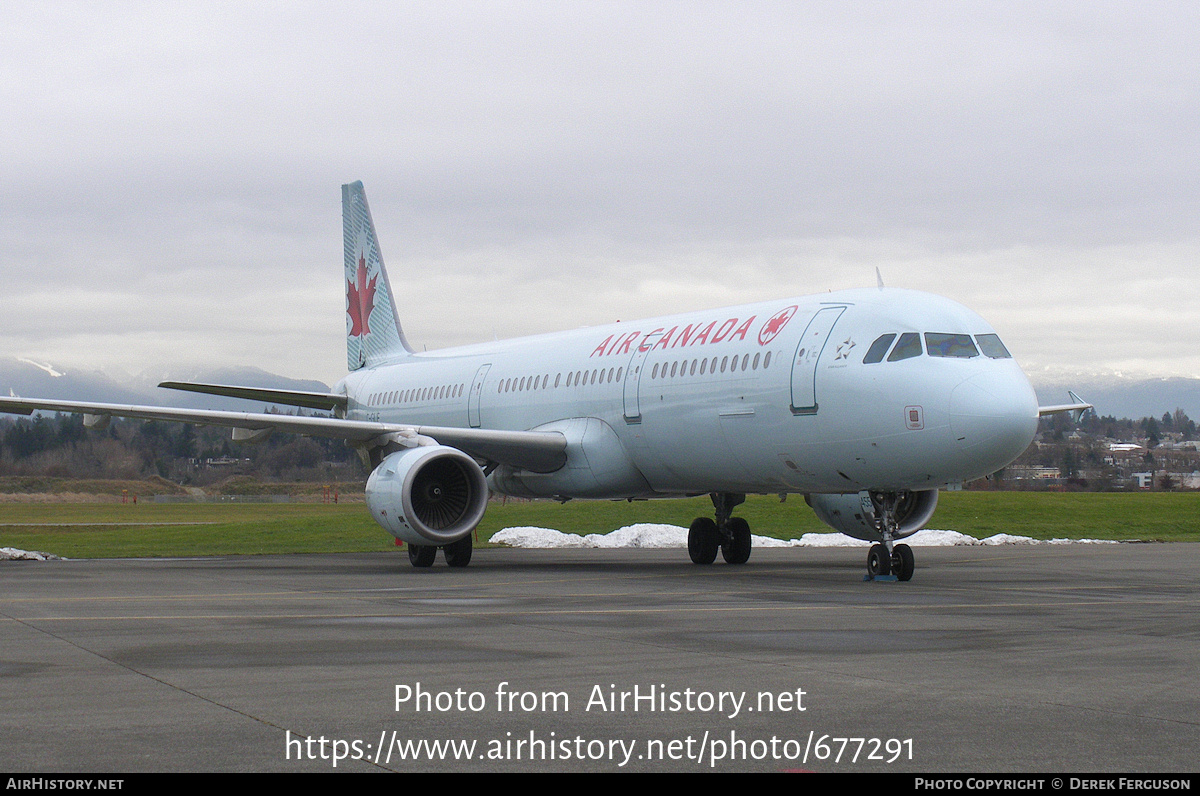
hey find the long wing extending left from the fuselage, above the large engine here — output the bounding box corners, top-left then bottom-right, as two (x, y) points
(0, 397), (566, 473)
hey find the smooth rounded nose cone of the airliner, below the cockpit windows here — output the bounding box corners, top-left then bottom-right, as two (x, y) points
(950, 371), (1038, 475)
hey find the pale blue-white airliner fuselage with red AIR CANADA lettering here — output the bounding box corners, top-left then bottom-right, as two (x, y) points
(335, 289), (1038, 497)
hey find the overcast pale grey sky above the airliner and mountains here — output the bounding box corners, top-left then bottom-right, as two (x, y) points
(0, 1), (1200, 383)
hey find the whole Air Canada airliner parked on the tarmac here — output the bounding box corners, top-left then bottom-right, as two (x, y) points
(0, 182), (1090, 580)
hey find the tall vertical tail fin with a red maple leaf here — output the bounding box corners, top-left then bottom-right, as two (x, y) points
(342, 182), (413, 371)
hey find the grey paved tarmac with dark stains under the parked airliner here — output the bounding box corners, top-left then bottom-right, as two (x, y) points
(0, 544), (1200, 772)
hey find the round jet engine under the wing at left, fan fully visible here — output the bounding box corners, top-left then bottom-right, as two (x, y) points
(367, 445), (487, 545)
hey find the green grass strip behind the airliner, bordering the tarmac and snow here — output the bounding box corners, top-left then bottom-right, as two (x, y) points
(0, 492), (1200, 558)
